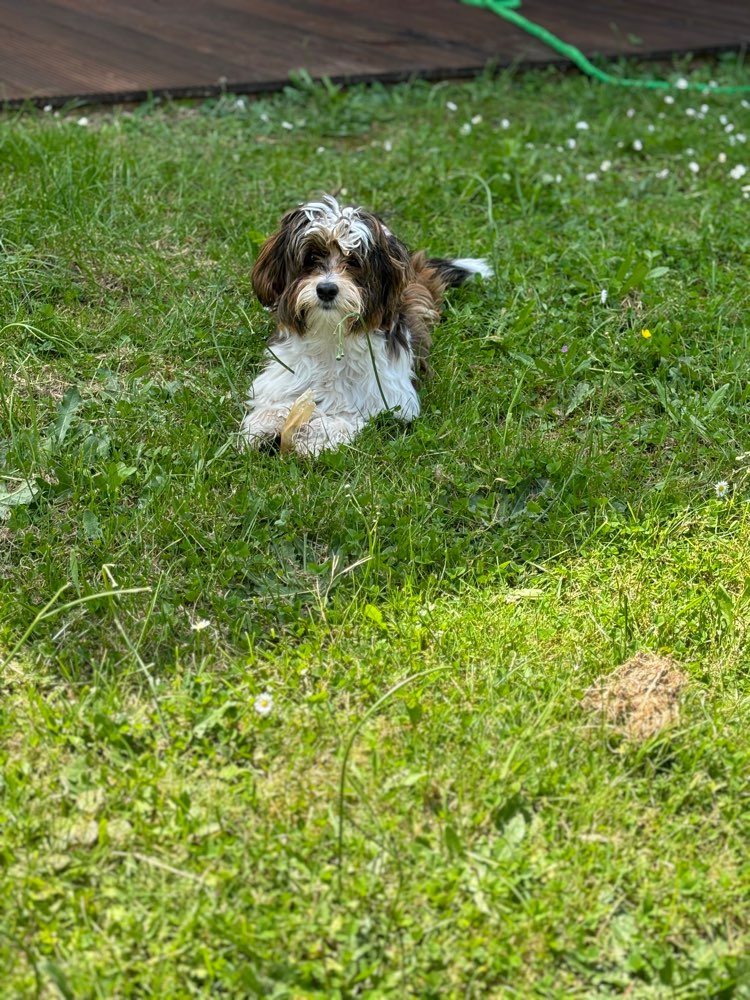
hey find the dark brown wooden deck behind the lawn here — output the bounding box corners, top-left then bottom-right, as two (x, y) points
(0, 0), (750, 105)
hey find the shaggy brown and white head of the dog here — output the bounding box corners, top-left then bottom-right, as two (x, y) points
(253, 196), (411, 335)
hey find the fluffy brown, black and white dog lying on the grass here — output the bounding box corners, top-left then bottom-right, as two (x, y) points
(241, 195), (492, 456)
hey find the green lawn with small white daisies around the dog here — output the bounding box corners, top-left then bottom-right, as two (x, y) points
(0, 58), (750, 1000)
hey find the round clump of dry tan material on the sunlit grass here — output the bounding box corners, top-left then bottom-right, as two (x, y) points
(583, 653), (687, 740)
